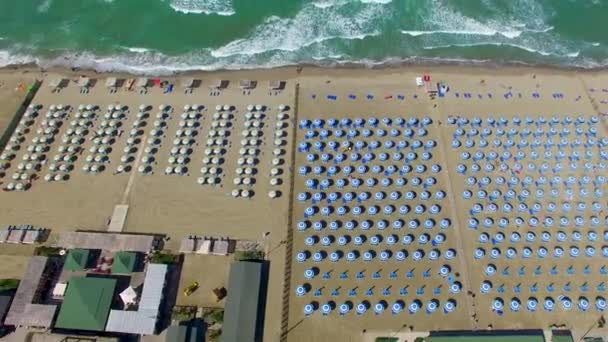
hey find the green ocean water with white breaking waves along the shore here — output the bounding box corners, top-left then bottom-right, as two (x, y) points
(0, 0), (608, 74)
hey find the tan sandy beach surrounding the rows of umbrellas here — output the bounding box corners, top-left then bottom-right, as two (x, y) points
(0, 66), (608, 341)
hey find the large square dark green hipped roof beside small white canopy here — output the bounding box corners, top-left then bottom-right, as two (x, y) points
(55, 277), (116, 331)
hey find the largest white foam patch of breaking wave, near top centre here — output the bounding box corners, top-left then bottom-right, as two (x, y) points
(211, 4), (385, 58)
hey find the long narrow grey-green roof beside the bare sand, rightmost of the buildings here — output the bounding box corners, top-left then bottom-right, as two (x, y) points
(221, 261), (263, 342)
